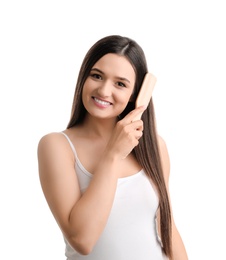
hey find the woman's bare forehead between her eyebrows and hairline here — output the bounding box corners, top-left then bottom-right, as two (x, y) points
(93, 53), (135, 79)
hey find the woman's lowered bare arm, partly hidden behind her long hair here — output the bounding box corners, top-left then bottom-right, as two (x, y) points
(159, 137), (188, 260)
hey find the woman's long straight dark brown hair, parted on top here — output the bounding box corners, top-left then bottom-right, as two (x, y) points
(67, 35), (172, 257)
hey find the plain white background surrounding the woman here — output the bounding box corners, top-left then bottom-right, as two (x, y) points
(0, 0), (226, 260)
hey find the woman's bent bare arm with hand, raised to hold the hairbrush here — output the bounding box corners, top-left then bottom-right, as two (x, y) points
(38, 105), (143, 254)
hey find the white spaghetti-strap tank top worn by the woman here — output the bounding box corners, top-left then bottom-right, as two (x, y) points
(62, 132), (166, 260)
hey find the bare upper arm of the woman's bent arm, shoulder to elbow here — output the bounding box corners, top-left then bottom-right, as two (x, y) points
(38, 133), (80, 230)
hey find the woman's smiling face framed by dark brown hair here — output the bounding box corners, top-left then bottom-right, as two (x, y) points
(82, 53), (136, 119)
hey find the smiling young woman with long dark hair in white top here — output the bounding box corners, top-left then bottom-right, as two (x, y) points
(38, 35), (188, 260)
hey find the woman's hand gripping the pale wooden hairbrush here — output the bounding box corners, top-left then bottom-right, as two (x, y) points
(106, 106), (145, 159)
